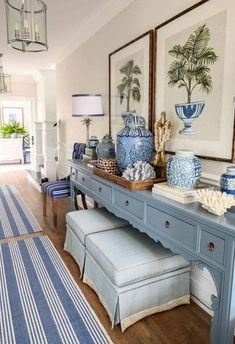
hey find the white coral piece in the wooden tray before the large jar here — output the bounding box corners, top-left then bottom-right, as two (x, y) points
(122, 161), (156, 181)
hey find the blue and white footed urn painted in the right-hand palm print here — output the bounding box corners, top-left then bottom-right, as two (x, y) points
(175, 101), (205, 135)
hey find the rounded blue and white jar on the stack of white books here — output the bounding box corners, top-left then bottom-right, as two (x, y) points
(166, 150), (202, 189)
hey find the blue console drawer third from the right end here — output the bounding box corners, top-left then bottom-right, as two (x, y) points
(114, 190), (144, 219)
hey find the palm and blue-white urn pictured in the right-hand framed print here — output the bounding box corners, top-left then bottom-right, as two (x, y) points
(167, 24), (218, 134)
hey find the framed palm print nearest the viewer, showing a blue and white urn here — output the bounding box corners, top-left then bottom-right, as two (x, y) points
(155, 0), (235, 162)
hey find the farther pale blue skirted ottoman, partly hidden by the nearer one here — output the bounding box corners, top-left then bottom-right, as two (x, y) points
(64, 208), (128, 276)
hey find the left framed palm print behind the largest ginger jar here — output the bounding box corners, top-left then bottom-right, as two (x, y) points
(109, 30), (153, 139)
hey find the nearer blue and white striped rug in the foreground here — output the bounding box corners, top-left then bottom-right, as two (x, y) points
(0, 236), (111, 344)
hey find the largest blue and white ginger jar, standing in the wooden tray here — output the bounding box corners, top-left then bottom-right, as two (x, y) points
(116, 112), (153, 172)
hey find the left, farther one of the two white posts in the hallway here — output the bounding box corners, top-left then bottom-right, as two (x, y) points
(33, 122), (43, 172)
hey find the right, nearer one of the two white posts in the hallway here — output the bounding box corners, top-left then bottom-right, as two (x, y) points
(42, 121), (57, 180)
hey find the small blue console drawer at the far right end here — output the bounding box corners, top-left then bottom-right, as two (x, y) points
(199, 230), (225, 265)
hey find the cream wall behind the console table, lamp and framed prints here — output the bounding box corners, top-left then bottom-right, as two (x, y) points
(57, 0), (234, 314)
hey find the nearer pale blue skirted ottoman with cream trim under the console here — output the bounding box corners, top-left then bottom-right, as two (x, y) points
(83, 226), (190, 331)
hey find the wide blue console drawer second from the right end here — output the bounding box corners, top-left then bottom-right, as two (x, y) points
(147, 205), (197, 250)
